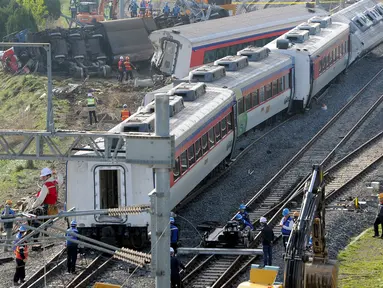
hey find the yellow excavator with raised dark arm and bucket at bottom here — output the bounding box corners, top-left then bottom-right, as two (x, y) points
(238, 165), (338, 288)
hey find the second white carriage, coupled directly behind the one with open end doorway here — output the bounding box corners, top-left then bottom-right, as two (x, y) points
(144, 47), (293, 137)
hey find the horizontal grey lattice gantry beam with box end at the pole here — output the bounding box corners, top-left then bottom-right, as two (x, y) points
(0, 130), (175, 168)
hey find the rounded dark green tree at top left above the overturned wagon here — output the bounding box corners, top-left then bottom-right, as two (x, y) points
(5, 7), (37, 34)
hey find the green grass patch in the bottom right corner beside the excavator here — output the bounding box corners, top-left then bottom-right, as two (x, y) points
(338, 228), (383, 288)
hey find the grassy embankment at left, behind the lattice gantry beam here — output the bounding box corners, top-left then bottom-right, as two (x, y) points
(0, 72), (70, 205)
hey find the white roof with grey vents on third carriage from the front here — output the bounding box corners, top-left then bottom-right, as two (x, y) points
(266, 16), (349, 55)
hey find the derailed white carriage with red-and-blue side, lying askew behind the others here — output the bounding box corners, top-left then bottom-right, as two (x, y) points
(149, 5), (327, 79)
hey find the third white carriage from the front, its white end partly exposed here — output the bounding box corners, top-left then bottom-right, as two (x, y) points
(266, 16), (349, 109)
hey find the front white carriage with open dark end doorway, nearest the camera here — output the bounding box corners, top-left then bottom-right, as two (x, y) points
(66, 83), (235, 248)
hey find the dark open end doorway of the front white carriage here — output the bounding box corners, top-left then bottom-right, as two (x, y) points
(94, 166), (127, 223)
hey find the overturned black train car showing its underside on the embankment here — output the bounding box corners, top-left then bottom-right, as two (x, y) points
(2, 18), (157, 78)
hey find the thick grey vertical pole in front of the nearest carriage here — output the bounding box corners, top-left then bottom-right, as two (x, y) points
(150, 94), (170, 288)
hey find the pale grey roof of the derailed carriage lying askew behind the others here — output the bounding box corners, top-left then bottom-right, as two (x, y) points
(151, 5), (328, 46)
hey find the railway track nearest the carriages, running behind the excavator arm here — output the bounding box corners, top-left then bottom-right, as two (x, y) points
(182, 69), (383, 288)
